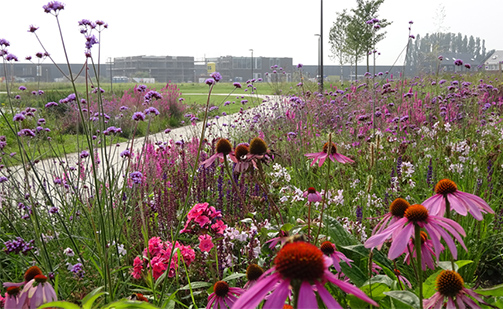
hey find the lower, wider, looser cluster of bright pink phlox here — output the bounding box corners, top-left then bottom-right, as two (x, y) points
(131, 237), (196, 280)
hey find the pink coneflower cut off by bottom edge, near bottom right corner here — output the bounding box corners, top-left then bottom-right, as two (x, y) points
(424, 270), (485, 309)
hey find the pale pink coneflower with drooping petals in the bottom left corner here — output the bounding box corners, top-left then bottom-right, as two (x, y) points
(20, 275), (58, 308)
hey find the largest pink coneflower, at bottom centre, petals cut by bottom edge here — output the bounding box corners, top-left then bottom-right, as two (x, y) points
(232, 242), (378, 308)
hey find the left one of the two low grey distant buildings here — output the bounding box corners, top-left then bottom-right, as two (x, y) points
(108, 56), (195, 83)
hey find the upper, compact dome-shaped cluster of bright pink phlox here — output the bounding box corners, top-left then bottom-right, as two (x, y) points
(180, 203), (227, 235)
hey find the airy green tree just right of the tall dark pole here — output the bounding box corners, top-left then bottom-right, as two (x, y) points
(329, 0), (391, 75)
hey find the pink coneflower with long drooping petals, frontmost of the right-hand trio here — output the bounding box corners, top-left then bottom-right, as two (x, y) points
(365, 204), (467, 260)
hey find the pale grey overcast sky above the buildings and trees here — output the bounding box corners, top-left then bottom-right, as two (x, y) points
(0, 0), (503, 65)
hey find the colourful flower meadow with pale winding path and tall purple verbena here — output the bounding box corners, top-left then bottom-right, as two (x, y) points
(0, 1), (503, 309)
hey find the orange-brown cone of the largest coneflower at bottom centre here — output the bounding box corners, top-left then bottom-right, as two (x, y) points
(274, 241), (325, 281)
